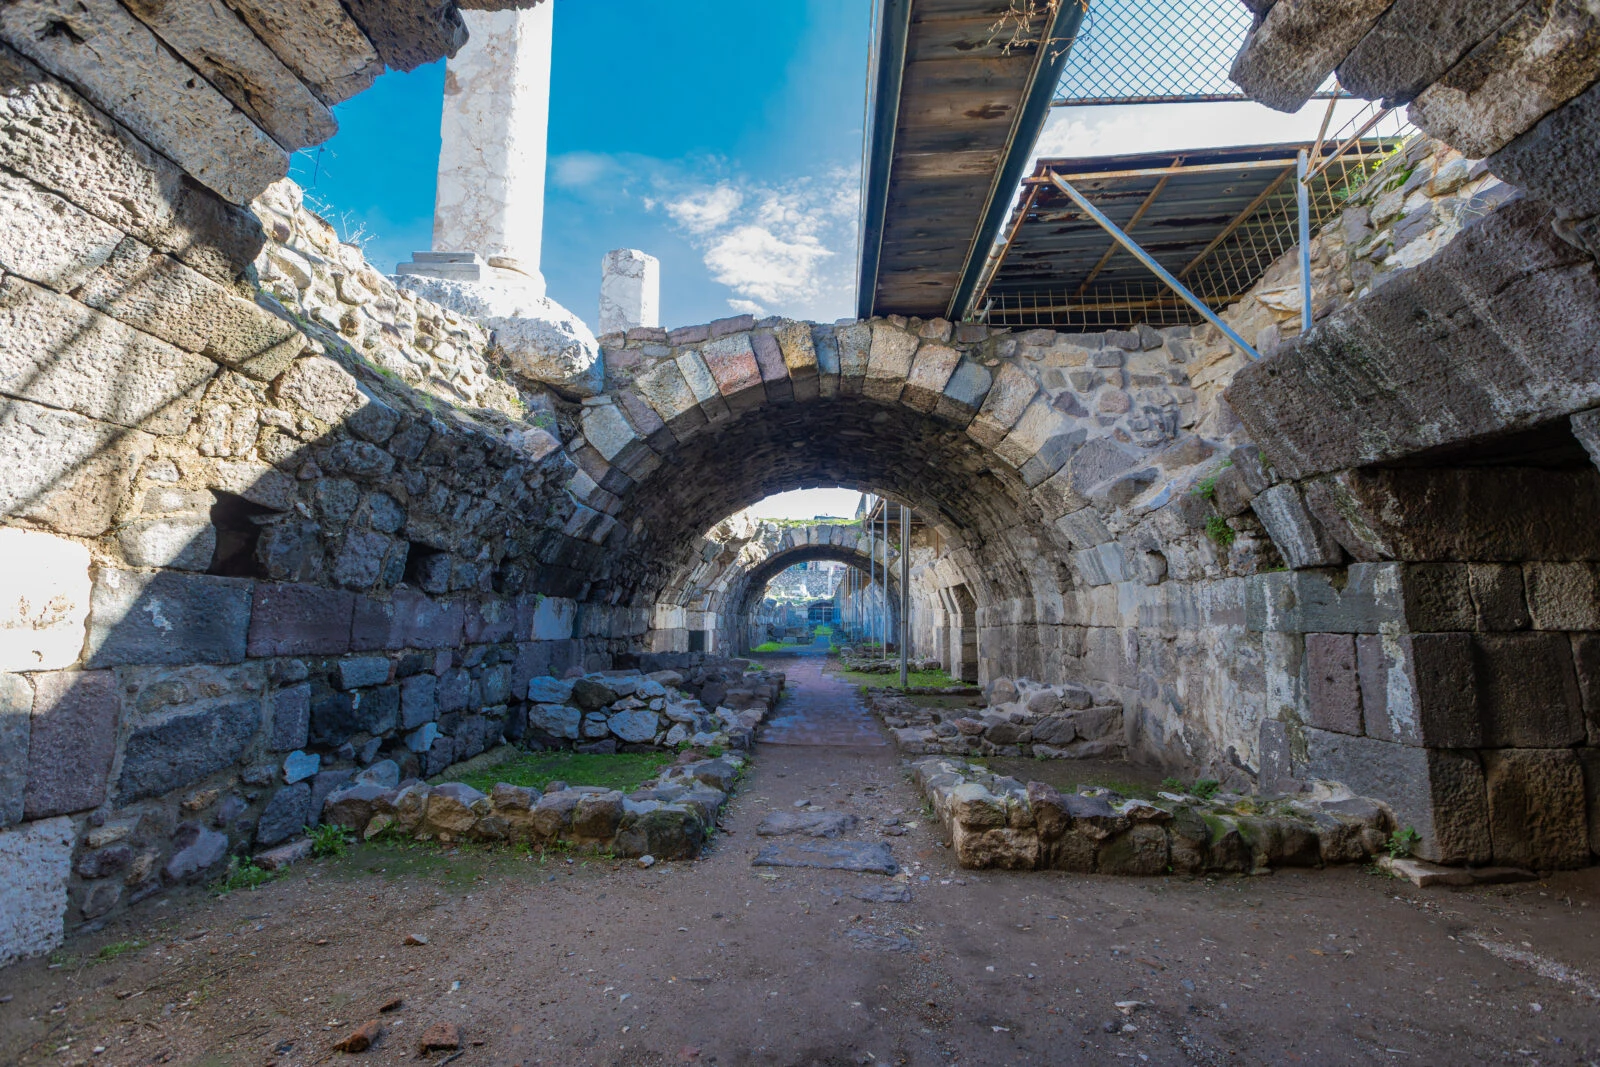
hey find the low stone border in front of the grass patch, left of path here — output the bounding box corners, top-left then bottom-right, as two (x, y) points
(322, 753), (746, 859)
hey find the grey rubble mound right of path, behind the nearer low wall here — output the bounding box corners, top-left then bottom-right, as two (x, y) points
(867, 678), (1126, 760)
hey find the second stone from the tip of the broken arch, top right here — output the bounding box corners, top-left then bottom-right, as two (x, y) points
(1339, 0), (1523, 104)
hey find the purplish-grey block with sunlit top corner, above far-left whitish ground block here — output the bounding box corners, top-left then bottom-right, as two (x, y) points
(24, 670), (118, 819)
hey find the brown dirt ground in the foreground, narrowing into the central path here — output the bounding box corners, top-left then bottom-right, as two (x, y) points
(0, 659), (1600, 1067)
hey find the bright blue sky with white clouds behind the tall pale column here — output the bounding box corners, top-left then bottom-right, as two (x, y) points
(294, 0), (870, 326)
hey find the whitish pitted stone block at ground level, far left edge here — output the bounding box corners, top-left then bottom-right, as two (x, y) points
(0, 817), (77, 966)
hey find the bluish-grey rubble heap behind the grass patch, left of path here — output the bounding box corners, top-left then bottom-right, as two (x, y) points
(528, 659), (784, 752)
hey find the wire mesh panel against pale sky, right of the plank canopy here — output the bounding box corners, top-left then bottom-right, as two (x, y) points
(1054, 0), (1334, 107)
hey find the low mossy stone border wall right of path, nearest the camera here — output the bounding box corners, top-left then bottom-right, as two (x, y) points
(912, 757), (1392, 875)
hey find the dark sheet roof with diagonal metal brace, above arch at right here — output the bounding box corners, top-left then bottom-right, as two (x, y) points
(976, 142), (1395, 330)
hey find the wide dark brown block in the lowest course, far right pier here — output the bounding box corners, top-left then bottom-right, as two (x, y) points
(1483, 749), (1589, 870)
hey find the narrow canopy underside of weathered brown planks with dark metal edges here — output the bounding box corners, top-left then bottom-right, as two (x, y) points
(856, 0), (1083, 318)
